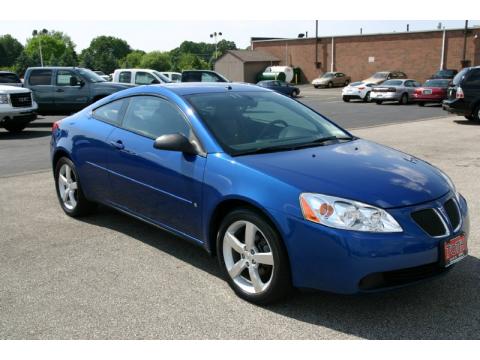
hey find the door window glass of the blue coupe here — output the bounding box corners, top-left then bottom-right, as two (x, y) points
(122, 96), (190, 139)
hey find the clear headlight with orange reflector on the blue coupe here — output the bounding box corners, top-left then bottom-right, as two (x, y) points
(300, 193), (403, 233)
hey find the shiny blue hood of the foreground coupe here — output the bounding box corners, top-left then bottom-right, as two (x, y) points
(236, 139), (451, 208)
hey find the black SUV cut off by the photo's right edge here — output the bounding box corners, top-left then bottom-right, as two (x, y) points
(442, 66), (480, 122)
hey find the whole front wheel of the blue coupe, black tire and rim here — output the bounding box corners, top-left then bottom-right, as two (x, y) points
(217, 208), (292, 305)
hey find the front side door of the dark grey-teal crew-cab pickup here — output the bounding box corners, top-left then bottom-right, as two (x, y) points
(55, 69), (90, 113)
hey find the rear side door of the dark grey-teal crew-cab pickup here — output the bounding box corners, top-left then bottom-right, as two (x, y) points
(26, 69), (55, 112)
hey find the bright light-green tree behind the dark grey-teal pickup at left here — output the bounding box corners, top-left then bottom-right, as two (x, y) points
(24, 30), (77, 66)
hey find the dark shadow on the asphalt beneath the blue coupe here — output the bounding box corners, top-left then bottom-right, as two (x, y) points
(78, 206), (480, 339)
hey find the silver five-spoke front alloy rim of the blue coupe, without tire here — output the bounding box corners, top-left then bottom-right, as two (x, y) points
(223, 220), (275, 294)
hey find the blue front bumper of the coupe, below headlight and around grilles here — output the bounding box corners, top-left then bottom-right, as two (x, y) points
(270, 193), (469, 294)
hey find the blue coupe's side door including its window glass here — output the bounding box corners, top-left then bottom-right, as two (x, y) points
(108, 95), (206, 238)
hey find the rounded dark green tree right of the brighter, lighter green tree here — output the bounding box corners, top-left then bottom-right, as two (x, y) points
(80, 36), (132, 74)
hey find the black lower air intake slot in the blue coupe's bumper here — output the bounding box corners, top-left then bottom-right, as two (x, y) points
(358, 263), (448, 290)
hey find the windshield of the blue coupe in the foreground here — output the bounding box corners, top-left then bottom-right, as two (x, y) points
(186, 91), (351, 155)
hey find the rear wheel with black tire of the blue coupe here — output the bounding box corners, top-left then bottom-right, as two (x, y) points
(54, 157), (95, 217)
